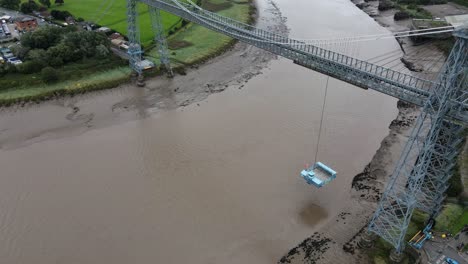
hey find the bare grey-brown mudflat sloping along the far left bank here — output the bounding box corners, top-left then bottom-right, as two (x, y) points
(0, 2), (287, 149)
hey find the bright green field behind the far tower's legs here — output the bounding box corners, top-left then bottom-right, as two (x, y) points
(50, 0), (181, 45)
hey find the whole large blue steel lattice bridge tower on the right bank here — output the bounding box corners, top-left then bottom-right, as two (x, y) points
(368, 30), (468, 259)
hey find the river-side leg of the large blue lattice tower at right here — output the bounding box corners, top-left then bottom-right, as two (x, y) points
(369, 29), (468, 255)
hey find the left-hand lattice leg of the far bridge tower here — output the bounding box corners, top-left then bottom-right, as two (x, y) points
(127, 0), (142, 76)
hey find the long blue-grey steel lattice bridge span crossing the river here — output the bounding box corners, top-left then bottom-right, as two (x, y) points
(138, 0), (468, 122)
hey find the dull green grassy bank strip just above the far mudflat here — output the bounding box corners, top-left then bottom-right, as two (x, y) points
(0, 0), (256, 106)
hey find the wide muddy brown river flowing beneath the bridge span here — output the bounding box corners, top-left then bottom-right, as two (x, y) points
(0, 0), (398, 264)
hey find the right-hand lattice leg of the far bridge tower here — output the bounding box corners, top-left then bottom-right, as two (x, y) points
(148, 6), (173, 77)
